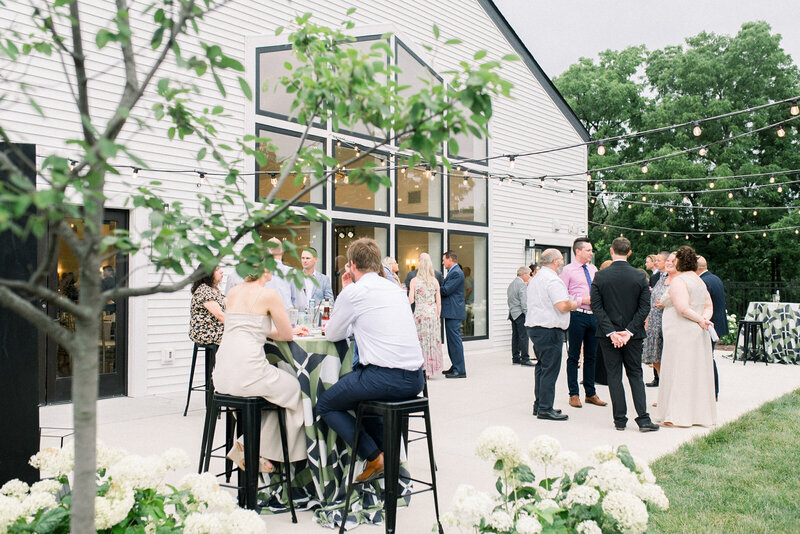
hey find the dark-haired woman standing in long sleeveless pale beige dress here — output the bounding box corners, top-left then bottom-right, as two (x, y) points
(655, 246), (717, 427)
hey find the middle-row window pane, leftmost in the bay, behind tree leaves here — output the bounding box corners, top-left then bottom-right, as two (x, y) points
(256, 128), (325, 205)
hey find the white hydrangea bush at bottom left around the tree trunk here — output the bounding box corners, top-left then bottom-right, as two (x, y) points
(0, 443), (266, 534)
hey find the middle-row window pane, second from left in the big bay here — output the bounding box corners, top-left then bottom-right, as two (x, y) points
(333, 147), (389, 213)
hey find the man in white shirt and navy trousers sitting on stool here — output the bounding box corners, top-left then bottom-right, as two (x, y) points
(317, 237), (425, 482)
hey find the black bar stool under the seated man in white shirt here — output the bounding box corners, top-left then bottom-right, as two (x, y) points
(339, 397), (444, 534)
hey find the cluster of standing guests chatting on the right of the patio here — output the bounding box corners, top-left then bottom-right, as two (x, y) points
(507, 237), (727, 432)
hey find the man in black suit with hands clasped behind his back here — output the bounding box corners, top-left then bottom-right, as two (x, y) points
(591, 241), (658, 432)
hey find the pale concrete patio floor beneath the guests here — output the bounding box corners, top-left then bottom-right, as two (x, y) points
(41, 350), (800, 534)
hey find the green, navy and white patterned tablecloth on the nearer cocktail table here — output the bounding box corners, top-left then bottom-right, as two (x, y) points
(264, 338), (411, 530)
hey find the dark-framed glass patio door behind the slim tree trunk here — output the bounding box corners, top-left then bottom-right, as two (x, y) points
(40, 210), (128, 404)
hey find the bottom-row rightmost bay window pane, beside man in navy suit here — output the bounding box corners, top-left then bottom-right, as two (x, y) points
(448, 231), (489, 338)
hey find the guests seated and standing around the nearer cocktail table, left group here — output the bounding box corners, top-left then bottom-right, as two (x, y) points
(189, 238), (466, 481)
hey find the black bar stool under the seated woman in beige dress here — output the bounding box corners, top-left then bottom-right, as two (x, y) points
(200, 392), (297, 523)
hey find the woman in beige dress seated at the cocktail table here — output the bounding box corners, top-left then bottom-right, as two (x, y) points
(213, 270), (307, 473)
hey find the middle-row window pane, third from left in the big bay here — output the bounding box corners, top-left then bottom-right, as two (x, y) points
(395, 158), (443, 220)
